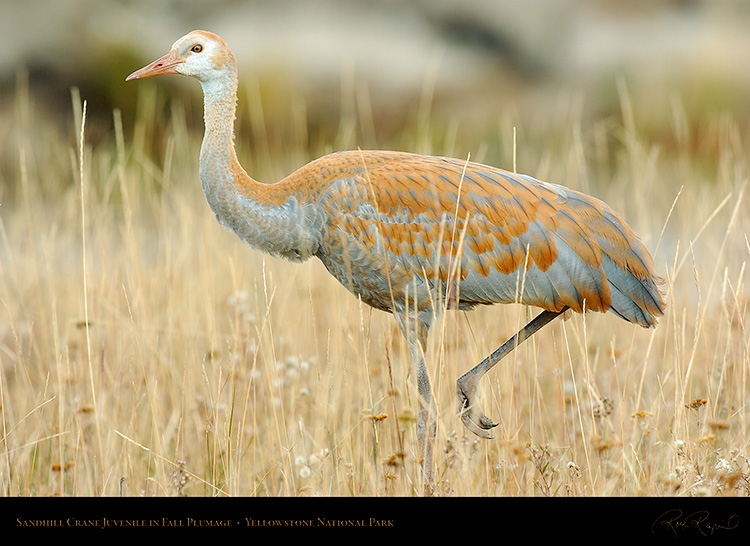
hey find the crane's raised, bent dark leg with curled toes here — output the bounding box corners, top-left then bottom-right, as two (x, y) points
(456, 306), (568, 438)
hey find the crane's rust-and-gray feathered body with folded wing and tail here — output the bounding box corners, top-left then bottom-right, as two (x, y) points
(270, 151), (664, 326)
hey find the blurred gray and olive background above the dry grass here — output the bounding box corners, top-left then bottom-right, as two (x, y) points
(0, 0), (750, 153)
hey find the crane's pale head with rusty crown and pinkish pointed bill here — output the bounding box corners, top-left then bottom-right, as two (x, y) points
(125, 30), (234, 81)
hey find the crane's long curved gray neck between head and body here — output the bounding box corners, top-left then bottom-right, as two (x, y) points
(200, 72), (318, 261)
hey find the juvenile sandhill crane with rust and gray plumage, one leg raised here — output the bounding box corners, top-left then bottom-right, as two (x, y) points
(127, 31), (665, 492)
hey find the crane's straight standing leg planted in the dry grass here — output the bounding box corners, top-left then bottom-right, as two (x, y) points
(396, 314), (437, 496)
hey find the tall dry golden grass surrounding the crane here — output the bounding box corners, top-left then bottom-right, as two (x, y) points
(0, 73), (750, 496)
